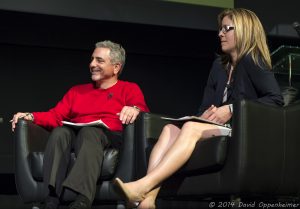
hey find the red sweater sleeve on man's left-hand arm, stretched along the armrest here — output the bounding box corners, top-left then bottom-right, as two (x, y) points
(33, 87), (75, 129)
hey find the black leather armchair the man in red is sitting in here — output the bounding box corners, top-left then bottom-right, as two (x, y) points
(14, 119), (135, 208)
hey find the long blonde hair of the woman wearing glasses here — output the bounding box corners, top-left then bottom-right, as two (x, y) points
(218, 8), (272, 69)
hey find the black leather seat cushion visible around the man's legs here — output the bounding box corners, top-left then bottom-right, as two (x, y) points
(29, 148), (119, 181)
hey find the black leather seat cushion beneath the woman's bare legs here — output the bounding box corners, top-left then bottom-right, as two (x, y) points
(178, 136), (230, 175)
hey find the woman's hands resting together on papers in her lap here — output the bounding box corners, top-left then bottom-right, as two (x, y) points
(201, 105), (232, 124)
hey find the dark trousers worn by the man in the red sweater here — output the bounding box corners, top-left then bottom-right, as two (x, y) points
(44, 126), (122, 202)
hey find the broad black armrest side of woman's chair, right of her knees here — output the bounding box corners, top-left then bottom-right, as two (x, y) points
(221, 100), (285, 192)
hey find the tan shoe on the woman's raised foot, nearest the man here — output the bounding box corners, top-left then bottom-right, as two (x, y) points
(113, 178), (145, 208)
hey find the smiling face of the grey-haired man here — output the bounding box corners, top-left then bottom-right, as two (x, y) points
(90, 48), (120, 82)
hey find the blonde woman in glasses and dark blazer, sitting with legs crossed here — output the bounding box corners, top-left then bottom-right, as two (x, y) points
(115, 8), (283, 209)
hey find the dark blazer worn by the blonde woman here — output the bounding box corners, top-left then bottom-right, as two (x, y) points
(198, 55), (284, 115)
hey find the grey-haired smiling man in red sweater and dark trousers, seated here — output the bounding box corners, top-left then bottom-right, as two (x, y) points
(12, 41), (149, 209)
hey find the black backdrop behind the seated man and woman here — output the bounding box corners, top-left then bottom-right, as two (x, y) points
(0, 0), (300, 194)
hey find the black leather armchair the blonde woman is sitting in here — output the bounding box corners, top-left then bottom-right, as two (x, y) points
(135, 100), (300, 204)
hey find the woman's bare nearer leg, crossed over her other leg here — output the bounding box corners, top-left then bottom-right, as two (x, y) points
(120, 122), (220, 201)
